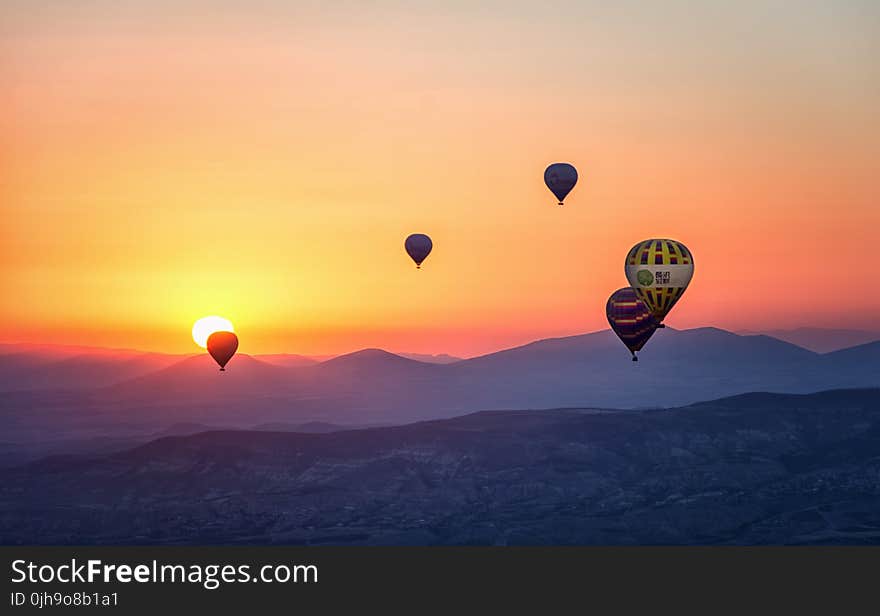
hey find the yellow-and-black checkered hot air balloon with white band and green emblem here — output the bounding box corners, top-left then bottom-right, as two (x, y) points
(625, 239), (694, 327)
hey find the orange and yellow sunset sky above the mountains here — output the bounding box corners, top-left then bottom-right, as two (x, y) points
(0, 0), (880, 356)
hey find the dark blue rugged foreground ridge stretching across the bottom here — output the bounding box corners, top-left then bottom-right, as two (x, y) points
(6, 389), (880, 545)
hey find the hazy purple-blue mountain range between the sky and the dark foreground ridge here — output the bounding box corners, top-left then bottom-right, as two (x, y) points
(0, 328), (880, 461)
